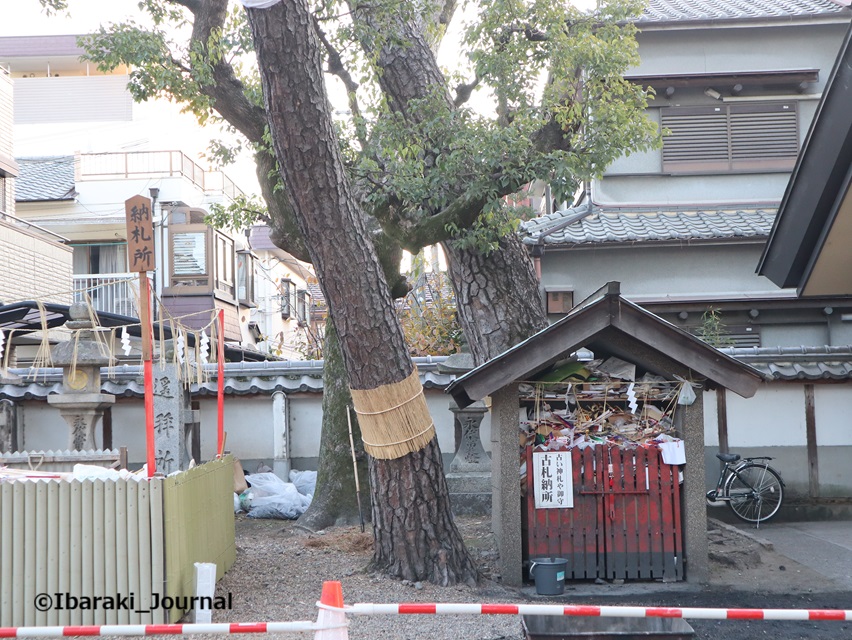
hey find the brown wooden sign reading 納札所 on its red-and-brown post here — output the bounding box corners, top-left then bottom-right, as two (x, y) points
(124, 196), (157, 478)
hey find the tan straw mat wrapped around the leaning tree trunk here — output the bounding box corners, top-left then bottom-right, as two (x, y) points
(350, 367), (435, 460)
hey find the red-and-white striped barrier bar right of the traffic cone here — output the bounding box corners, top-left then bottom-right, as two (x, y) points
(343, 602), (852, 620)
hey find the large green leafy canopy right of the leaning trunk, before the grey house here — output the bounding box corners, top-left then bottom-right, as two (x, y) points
(346, 0), (659, 252)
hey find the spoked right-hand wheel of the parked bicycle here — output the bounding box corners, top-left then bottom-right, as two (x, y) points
(725, 462), (784, 523)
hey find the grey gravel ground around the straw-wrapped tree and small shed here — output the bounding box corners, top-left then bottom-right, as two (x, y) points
(205, 516), (852, 640)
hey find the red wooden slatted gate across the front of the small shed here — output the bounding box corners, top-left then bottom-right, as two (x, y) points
(523, 446), (684, 581)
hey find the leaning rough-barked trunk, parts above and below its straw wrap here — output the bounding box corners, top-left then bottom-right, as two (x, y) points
(248, 0), (479, 584)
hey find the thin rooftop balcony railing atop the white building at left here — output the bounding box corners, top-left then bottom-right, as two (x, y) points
(80, 151), (243, 200)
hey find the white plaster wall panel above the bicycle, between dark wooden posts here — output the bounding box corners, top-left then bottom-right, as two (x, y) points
(724, 384), (807, 452)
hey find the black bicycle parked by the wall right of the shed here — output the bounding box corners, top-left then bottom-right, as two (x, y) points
(707, 453), (784, 527)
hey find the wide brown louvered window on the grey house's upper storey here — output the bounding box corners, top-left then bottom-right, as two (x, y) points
(660, 101), (799, 173)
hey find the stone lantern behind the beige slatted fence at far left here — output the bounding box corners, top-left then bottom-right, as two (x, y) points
(47, 302), (115, 451)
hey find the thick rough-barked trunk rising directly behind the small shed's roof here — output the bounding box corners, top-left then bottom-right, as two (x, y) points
(444, 234), (547, 365)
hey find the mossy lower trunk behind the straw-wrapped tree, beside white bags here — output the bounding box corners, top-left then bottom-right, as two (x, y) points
(298, 319), (370, 531)
